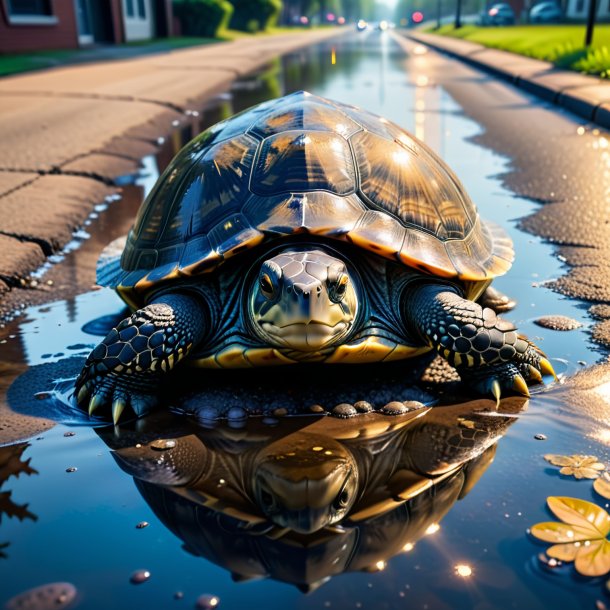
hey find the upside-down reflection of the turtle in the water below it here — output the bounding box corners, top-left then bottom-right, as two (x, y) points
(98, 397), (527, 591)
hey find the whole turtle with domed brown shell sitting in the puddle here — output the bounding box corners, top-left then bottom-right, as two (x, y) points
(75, 91), (555, 423)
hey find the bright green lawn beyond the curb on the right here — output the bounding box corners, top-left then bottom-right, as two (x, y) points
(424, 24), (610, 78)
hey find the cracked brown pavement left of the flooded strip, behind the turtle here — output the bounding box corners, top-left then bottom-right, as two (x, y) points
(0, 30), (344, 295)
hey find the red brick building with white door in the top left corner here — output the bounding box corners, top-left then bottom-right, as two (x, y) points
(0, 0), (173, 53)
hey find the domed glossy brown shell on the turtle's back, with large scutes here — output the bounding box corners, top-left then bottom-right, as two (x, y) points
(98, 91), (513, 300)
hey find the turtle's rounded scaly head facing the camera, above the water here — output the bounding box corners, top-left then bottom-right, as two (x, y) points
(250, 247), (358, 352)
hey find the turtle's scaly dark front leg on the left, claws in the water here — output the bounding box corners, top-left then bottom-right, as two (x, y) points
(75, 294), (204, 424)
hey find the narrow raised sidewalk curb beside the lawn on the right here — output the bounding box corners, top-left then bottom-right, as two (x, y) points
(397, 30), (610, 128)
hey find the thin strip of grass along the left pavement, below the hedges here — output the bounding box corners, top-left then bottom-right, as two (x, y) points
(0, 26), (325, 77)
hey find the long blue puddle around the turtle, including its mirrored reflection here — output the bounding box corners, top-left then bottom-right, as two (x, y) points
(0, 33), (610, 609)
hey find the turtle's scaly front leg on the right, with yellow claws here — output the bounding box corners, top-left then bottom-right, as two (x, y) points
(404, 284), (555, 400)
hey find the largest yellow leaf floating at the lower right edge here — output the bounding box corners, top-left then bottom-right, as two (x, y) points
(530, 496), (610, 576)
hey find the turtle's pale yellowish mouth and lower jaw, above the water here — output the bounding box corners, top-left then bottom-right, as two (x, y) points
(260, 320), (352, 351)
